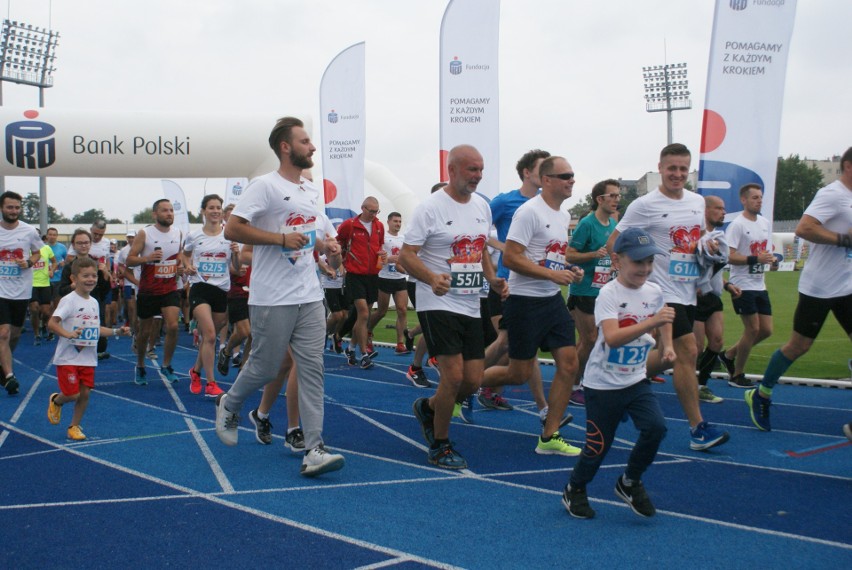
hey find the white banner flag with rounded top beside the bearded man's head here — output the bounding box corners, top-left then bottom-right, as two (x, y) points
(320, 42), (367, 226)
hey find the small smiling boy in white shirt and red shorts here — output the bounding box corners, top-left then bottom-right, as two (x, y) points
(47, 256), (130, 441)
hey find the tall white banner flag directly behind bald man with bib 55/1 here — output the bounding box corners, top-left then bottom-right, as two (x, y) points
(440, 0), (500, 198)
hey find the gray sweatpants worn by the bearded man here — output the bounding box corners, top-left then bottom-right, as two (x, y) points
(225, 301), (325, 450)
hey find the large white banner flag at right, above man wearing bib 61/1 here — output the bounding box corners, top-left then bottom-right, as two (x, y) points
(698, 0), (796, 226)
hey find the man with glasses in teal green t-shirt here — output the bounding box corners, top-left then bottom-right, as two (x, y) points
(565, 179), (621, 406)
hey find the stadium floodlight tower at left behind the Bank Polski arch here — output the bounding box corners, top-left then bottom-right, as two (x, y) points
(0, 19), (59, 231)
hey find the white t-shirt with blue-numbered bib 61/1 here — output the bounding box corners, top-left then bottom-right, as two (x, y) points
(615, 188), (704, 305)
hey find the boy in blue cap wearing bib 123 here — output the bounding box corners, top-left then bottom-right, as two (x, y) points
(562, 228), (675, 519)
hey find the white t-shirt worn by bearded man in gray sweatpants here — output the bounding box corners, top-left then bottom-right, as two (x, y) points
(232, 171), (336, 307)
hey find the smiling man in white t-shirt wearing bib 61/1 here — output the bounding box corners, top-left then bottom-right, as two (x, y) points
(606, 143), (729, 451)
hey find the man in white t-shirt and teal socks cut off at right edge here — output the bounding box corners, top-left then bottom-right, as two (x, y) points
(745, 147), (852, 431)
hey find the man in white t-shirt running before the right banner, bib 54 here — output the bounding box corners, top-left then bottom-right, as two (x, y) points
(719, 184), (776, 388)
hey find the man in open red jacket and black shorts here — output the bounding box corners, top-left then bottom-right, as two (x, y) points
(337, 196), (387, 369)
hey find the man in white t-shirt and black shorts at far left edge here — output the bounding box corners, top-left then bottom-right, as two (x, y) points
(0, 191), (44, 396)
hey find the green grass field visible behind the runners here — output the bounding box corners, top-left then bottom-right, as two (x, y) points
(375, 271), (852, 379)
